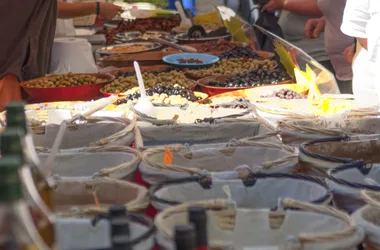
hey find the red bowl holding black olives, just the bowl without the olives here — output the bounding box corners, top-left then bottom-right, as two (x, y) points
(198, 76), (292, 96)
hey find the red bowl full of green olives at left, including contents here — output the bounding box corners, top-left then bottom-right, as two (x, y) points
(20, 73), (115, 102)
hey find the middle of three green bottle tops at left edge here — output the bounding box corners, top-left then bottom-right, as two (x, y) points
(0, 128), (24, 160)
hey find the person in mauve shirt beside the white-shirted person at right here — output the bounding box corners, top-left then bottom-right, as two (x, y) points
(305, 0), (355, 94)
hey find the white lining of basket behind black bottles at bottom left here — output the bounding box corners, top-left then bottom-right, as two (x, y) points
(55, 218), (154, 250)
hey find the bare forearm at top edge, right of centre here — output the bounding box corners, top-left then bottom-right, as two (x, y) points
(262, 0), (323, 17)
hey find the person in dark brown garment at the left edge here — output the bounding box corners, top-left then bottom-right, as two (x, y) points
(0, 0), (57, 110)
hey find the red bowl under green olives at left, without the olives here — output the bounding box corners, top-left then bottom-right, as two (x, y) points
(20, 74), (115, 102)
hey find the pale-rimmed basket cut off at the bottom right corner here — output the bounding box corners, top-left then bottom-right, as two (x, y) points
(352, 190), (380, 250)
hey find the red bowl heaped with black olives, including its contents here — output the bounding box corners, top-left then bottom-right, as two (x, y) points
(198, 68), (292, 96)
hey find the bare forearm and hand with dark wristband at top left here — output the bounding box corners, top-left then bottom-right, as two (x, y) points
(57, 2), (122, 20)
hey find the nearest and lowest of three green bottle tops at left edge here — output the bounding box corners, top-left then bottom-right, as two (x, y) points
(0, 156), (23, 203)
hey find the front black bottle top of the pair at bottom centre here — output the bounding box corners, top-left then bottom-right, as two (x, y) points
(174, 224), (195, 250)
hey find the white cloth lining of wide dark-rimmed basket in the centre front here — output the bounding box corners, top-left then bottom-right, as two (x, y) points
(152, 178), (328, 210)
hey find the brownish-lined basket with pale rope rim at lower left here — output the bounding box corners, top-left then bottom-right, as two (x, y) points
(53, 177), (149, 217)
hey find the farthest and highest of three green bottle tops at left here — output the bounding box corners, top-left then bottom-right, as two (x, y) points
(5, 102), (27, 134)
